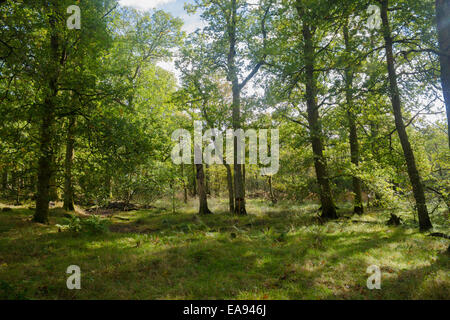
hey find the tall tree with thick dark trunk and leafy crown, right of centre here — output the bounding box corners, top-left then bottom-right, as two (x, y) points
(270, 0), (337, 219)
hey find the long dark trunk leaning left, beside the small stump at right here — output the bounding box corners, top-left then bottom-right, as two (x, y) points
(381, 0), (433, 231)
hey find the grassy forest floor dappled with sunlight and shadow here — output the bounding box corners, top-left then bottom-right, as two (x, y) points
(0, 199), (450, 299)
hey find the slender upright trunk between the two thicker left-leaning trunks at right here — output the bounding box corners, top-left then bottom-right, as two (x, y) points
(344, 23), (364, 214)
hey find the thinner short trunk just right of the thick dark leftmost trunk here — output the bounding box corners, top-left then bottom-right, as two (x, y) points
(64, 116), (76, 211)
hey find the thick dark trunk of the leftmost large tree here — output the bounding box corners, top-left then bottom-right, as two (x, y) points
(33, 11), (59, 223)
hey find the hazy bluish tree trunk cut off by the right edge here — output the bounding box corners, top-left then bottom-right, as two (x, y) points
(436, 0), (450, 148)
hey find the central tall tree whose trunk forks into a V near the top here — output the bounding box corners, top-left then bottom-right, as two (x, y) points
(188, 0), (272, 215)
